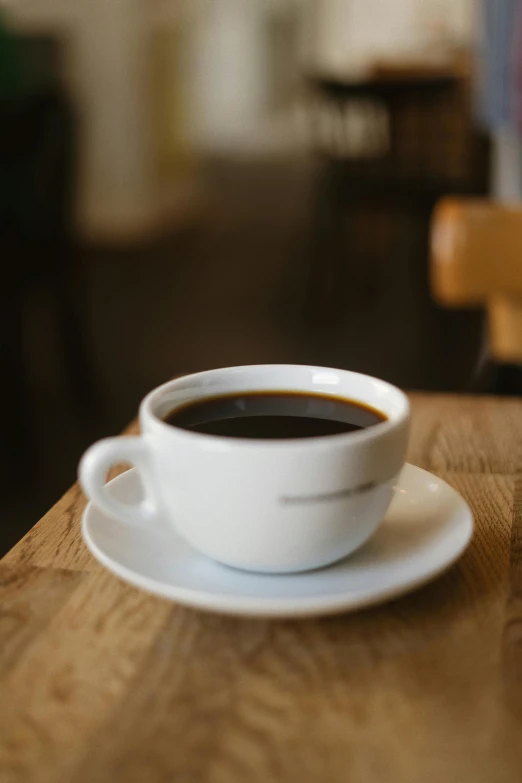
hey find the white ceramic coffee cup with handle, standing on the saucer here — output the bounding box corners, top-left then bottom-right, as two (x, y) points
(80, 365), (409, 572)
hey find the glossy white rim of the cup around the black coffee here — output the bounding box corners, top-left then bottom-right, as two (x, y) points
(139, 363), (410, 450)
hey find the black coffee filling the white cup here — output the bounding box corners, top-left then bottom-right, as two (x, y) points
(165, 391), (386, 440)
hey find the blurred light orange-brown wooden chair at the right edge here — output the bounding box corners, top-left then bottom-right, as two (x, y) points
(431, 197), (522, 394)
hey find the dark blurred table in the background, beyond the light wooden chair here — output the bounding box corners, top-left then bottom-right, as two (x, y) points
(300, 64), (488, 320)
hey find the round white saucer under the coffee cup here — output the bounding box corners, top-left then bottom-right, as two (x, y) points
(82, 465), (473, 617)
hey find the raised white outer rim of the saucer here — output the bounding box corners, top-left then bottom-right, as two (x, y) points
(81, 463), (474, 619)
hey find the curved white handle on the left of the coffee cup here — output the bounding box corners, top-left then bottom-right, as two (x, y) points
(79, 437), (158, 526)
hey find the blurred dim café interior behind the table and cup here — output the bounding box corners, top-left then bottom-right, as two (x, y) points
(0, 0), (522, 554)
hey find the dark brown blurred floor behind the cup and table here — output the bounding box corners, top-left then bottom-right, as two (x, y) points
(0, 159), (481, 554)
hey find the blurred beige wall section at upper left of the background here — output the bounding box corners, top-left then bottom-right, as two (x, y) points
(1, 0), (158, 239)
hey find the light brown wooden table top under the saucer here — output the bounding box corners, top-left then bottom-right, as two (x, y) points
(0, 395), (522, 783)
